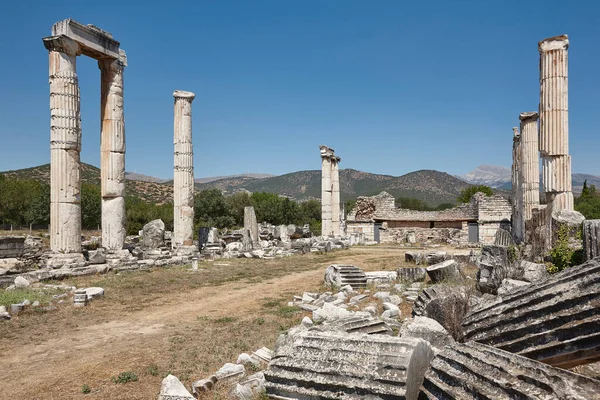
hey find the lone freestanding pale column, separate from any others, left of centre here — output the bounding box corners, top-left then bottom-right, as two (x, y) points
(173, 90), (196, 248)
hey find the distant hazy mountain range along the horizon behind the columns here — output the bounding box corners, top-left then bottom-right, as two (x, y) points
(2, 163), (600, 206)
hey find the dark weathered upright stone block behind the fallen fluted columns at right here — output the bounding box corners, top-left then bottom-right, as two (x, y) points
(477, 246), (511, 294)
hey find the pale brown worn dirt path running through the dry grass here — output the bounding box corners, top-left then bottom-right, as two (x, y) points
(0, 249), (406, 400)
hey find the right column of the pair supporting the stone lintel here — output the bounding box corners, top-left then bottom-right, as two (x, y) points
(98, 50), (127, 250)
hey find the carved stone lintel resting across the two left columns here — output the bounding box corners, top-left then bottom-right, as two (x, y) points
(52, 18), (120, 59)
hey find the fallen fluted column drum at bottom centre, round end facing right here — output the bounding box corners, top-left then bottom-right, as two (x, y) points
(264, 331), (433, 400)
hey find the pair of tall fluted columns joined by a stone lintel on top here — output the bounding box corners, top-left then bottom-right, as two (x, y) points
(43, 19), (127, 261)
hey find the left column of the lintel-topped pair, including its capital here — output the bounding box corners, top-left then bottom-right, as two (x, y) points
(43, 35), (81, 254)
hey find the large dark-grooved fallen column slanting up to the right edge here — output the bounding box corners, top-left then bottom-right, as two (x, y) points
(463, 259), (600, 368)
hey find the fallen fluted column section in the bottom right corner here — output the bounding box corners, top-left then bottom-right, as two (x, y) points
(419, 342), (600, 400)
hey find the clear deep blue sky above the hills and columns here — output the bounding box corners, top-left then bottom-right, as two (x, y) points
(0, 0), (600, 178)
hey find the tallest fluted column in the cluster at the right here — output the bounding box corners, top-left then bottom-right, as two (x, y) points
(538, 35), (573, 212)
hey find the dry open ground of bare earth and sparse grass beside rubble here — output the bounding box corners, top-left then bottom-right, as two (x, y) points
(0, 246), (412, 400)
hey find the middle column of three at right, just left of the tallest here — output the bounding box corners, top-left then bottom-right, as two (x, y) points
(519, 112), (540, 222)
